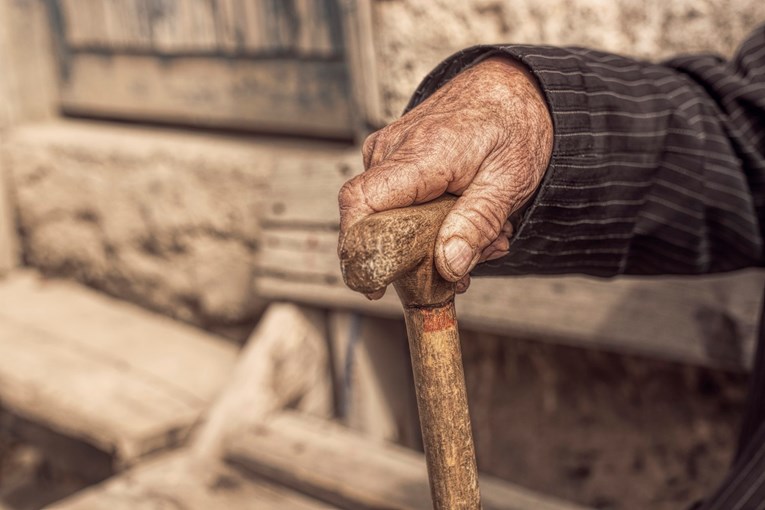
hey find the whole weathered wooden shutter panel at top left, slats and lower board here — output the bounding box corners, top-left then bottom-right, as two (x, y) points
(49, 0), (353, 138)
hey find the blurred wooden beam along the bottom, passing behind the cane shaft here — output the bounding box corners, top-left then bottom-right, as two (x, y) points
(226, 413), (583, 510)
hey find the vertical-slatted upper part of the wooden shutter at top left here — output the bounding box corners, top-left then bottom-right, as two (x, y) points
(56, 0), (343, 57)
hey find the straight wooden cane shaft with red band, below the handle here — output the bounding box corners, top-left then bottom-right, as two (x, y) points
(404, 300), (481, 510)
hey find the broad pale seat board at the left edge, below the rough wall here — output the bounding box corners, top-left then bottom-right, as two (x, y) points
(0, 272), (237, 468)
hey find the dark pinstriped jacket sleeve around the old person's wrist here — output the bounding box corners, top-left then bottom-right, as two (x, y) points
(408, 25), (765, 276)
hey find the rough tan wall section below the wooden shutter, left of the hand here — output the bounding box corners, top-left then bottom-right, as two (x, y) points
(1, 122), (350, 337)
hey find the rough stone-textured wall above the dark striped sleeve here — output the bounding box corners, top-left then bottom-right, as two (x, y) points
(372, 0), (765, 120)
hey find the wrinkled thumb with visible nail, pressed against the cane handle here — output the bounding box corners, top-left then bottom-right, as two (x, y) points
(435, 181), (511, 282)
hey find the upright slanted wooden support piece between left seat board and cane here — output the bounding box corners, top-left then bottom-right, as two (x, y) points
(193, 303), (333, 458)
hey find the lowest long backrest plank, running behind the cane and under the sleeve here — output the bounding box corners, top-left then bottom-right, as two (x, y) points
(255, 266), (763, 369)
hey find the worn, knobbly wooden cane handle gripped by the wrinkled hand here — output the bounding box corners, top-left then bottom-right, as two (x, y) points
(338, 195), (457, 306)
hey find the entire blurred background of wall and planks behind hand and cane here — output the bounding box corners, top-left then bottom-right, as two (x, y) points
(0, 0), (765, 510)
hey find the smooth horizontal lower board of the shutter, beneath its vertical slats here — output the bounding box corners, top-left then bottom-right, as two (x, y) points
(61, 54), (351, 137)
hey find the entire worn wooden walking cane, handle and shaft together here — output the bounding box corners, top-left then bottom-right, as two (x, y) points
(339, 196), (481, 510)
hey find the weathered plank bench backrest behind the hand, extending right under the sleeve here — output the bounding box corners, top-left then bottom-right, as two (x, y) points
(255, 153), (763, 368)
